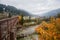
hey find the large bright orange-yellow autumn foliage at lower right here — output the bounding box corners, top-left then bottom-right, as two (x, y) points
(35, 18), (60, 40)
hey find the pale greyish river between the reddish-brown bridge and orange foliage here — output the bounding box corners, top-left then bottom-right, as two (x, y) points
(18, 25), (38, 40)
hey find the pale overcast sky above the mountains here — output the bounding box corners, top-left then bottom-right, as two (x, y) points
(0, 0), (60, 14)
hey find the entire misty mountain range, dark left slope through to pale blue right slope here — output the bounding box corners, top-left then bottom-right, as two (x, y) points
(0, 4), (60, 17)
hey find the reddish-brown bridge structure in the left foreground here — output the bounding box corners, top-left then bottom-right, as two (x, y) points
(0, 16), (19, 40)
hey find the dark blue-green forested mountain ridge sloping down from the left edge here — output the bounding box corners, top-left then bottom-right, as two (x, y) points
(0, 4), (30, 16)
